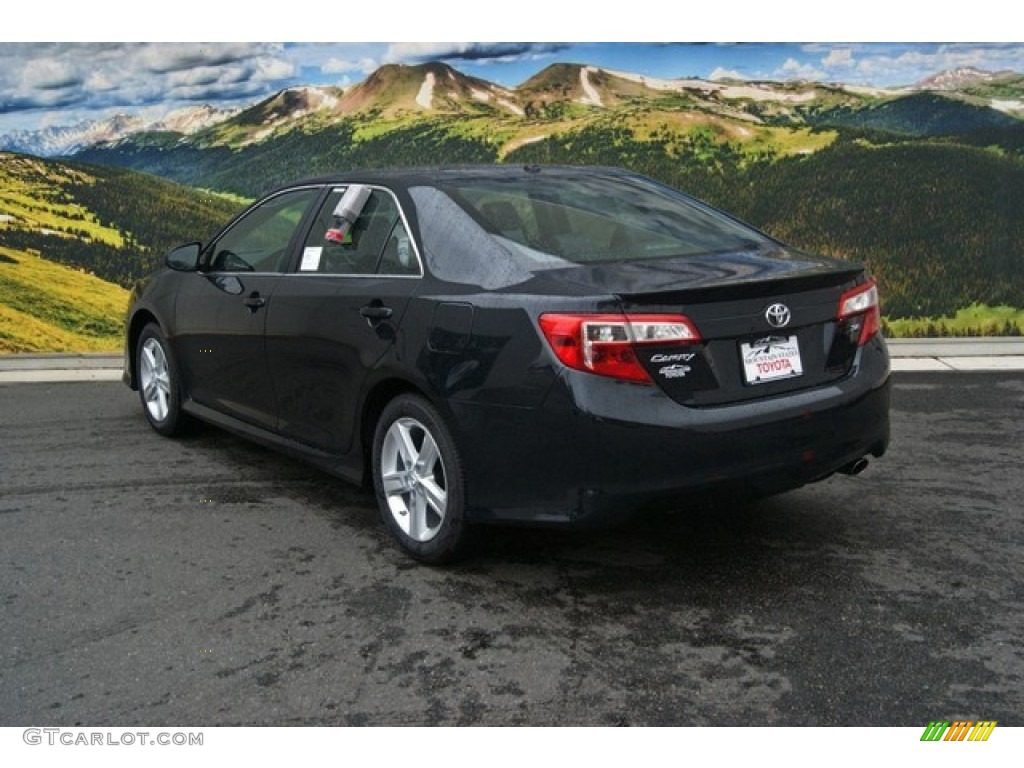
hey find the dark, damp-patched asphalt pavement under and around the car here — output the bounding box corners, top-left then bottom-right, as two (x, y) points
(0, 372), (1024, 728)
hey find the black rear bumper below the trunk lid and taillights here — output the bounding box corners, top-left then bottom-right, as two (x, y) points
(453, 338), (890, 525)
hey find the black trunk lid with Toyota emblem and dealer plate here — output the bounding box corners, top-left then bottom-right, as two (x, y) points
(547, 249), (863, 407)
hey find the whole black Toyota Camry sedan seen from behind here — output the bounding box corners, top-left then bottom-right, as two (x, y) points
(124, 166), (890, 562)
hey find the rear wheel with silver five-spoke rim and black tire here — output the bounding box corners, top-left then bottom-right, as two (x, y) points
(372, 394), (467, 564)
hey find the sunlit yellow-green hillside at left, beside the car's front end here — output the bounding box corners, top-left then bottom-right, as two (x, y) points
(0, 153), (247, 353)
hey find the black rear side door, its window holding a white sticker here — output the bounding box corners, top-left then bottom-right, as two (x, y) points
(266, 185), (422, 454)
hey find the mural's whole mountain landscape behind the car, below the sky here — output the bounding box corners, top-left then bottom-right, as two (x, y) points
(0, 62), (1024, 351)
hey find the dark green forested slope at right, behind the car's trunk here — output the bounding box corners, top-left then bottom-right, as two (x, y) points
(742, 142), (1024, 317)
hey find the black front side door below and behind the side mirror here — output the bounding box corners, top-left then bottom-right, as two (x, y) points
(173, 186), (321, 429)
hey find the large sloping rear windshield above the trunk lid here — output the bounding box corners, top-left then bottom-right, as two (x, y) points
(438, 172), (772, 269)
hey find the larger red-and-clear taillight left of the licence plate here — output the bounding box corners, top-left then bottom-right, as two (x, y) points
(540, 313), (700, 382)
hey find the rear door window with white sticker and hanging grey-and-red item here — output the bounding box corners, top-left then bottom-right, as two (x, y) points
(299, 186), (420, 274)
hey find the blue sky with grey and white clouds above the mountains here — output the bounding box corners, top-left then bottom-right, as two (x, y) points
(0, 42), (1024, 134)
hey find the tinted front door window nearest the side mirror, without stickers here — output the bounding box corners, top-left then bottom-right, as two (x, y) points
(208, 188), (319, 272)
